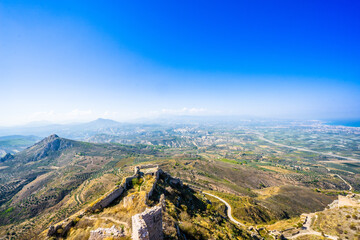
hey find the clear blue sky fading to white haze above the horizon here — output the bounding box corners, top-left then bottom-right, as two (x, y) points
(0, 0), (360, 125)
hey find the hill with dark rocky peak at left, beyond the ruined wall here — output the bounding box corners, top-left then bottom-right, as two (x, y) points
(0, 135), (162, 235)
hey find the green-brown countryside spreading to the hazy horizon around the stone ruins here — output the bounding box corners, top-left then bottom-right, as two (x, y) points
(0, 119), (360, 239)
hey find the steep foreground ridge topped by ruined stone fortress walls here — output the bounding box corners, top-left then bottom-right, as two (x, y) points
(42, 165), (256, 240)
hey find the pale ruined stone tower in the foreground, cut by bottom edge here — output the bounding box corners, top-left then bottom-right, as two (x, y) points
(131, 206), (164, 240)
